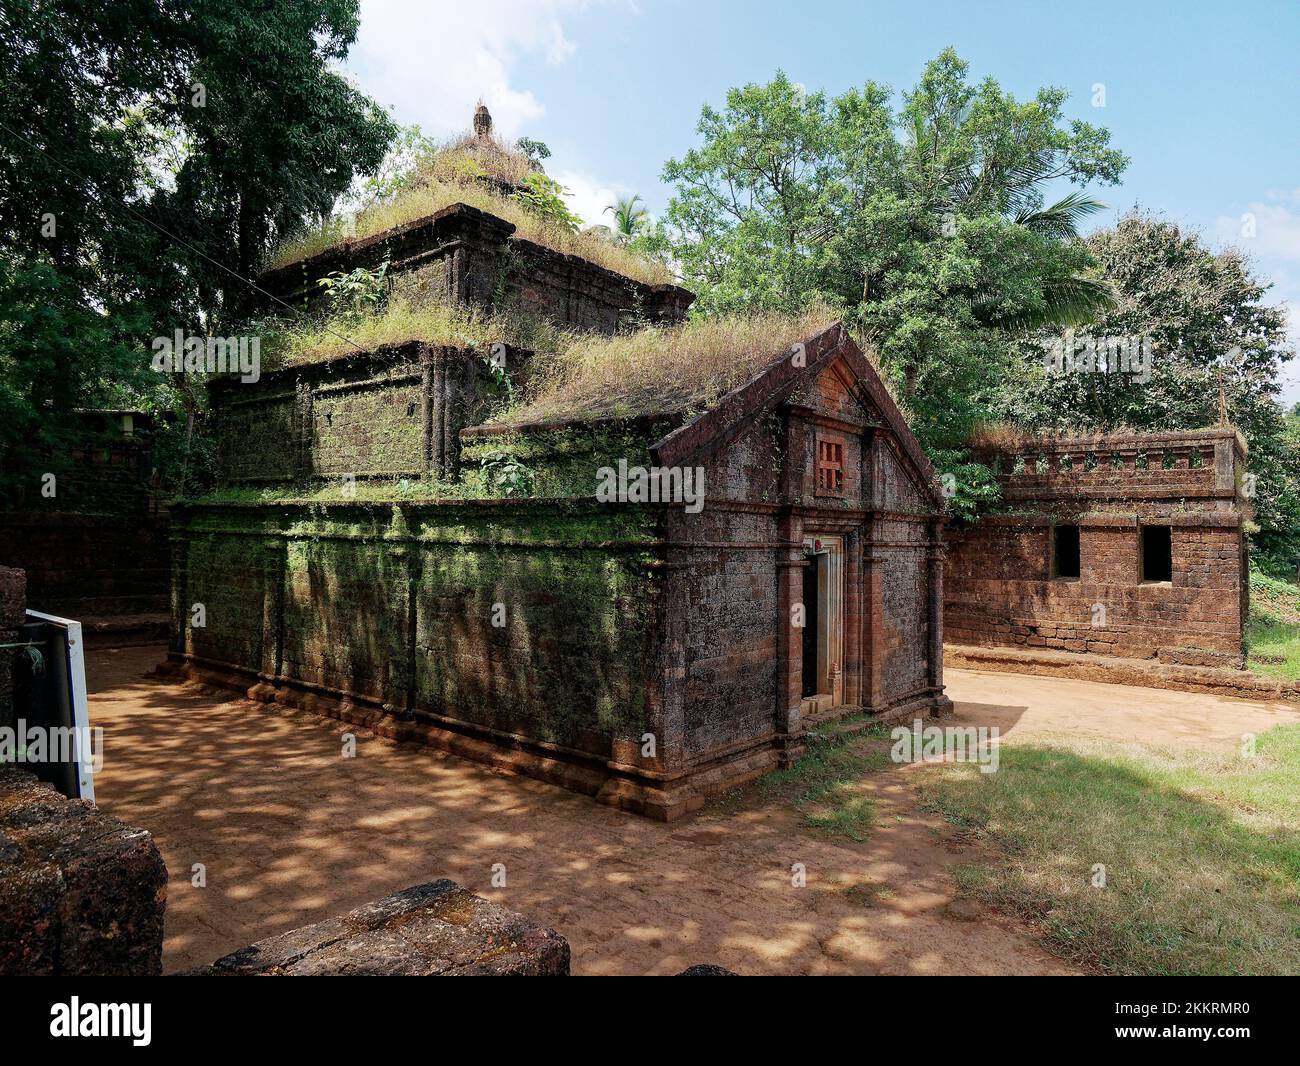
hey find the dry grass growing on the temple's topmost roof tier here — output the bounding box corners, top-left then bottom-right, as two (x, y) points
(267, 138), (675, 285)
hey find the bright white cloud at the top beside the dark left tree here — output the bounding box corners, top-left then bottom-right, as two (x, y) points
(347, 0), (589, 138)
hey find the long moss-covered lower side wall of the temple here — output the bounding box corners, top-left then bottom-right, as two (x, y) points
(174, 501), (662, 757)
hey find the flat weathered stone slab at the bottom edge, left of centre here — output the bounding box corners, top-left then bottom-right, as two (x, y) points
(195, 880), (569, 978)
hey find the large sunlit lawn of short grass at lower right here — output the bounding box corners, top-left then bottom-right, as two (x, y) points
(920, 725), (1300, 975)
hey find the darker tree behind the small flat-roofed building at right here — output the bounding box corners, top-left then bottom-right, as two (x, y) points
(998, 211), (1300, 572)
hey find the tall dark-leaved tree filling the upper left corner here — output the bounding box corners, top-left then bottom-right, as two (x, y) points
(0, 0), (394, 491)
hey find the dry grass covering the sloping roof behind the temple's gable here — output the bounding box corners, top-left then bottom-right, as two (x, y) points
(497, 307), (835, 424)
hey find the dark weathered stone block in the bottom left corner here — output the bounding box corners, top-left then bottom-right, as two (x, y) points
(0, 767), (166, 976)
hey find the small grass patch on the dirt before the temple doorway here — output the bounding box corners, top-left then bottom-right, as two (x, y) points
(755, 719), (892, 842)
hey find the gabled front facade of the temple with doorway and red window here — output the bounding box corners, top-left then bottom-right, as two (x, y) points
(654, 326), (945, 785)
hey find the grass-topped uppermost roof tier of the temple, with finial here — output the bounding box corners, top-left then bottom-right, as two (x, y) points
(259, 107), (694, 333)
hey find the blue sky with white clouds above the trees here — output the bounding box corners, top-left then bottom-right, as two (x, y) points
(347, 0), (1300, 403)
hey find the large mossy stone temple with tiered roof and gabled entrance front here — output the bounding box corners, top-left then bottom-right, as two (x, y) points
(172, 114), (948, 819)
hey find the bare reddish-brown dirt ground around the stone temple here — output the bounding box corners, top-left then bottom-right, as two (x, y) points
(88, 646), (1300, 974)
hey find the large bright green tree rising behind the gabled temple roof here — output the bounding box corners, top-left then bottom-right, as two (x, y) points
(655, 49), (1127, 449)
